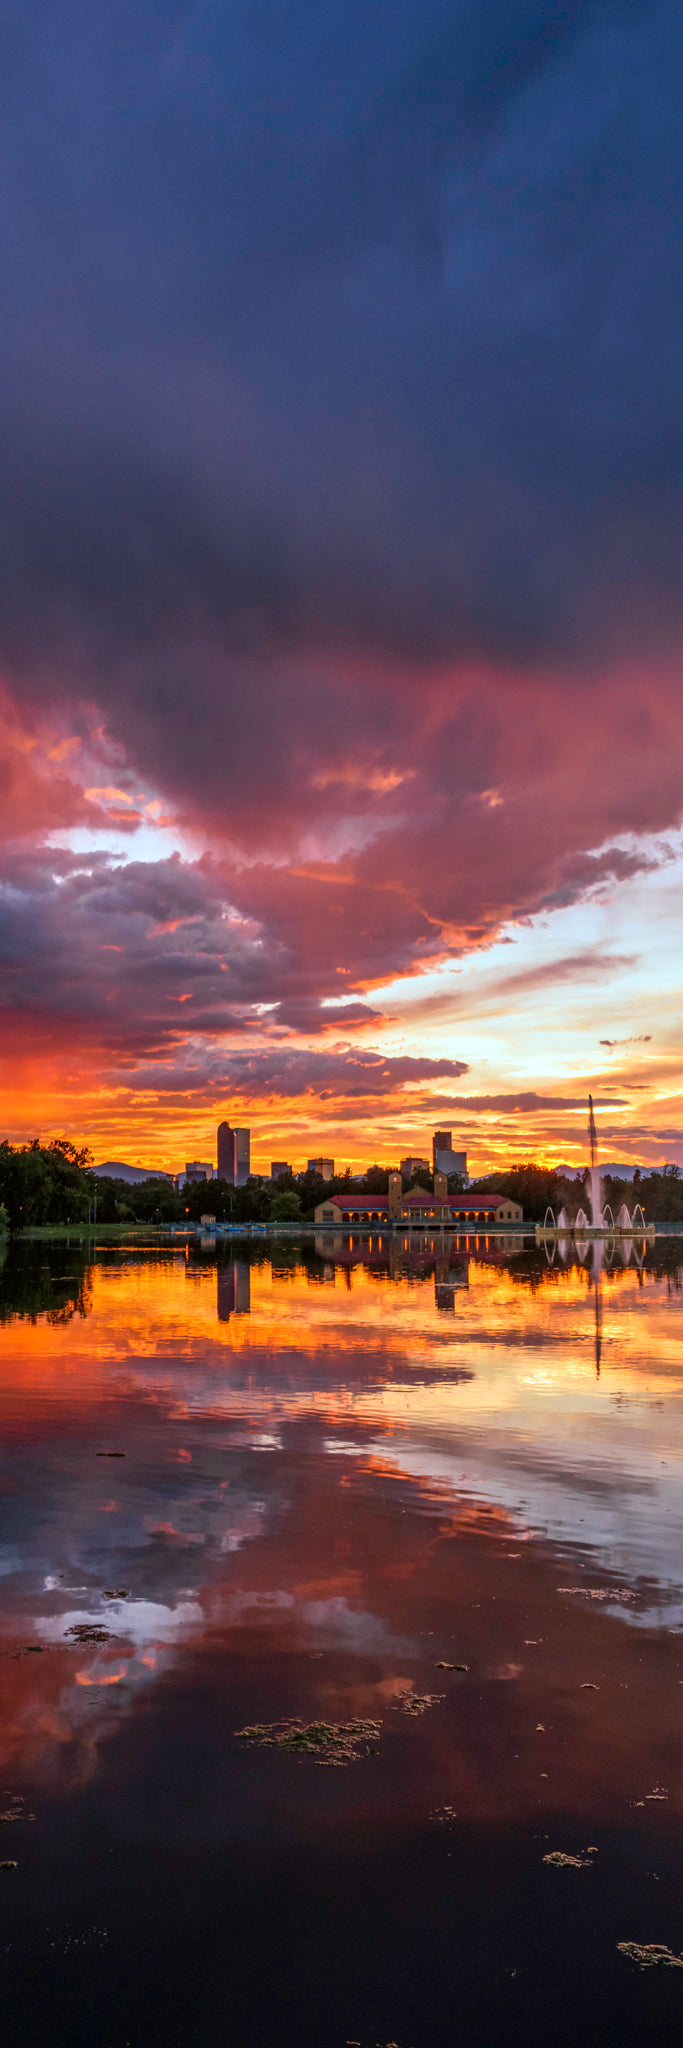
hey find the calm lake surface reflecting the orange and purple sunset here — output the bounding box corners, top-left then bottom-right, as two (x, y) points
(0, 1239), (683, 2048)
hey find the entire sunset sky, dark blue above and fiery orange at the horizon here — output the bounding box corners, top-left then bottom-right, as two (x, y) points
(0, 0), (683, 1171)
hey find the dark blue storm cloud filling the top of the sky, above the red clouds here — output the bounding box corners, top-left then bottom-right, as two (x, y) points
(0, 0), (683, 684)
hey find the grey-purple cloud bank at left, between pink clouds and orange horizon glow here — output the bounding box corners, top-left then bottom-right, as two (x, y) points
(0, 848), (436, 1071)
